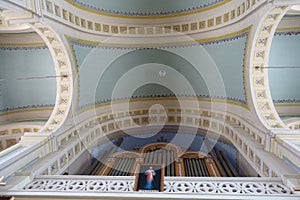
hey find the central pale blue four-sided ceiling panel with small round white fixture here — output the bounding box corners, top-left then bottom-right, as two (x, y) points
(69, 28), (250, 109)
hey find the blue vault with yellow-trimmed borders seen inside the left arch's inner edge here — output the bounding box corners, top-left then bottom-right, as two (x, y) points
(0, 25), (57, 150)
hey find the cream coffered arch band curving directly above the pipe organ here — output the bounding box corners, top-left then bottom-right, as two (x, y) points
(52, 101), (282, 176)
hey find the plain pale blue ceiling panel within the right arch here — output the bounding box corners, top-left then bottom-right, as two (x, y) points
(268, 31), (300, 103)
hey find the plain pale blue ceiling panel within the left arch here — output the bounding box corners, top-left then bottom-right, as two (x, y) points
(0, 46), (56, 112)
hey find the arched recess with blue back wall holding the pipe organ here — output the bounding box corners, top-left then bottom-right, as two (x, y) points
(68, 126), (257, 177)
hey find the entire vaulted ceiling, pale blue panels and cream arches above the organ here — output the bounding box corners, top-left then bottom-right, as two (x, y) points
(0, 0), (300, 183)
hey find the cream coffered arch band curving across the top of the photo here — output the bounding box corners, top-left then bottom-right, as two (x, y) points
(43, 0), (266, 37)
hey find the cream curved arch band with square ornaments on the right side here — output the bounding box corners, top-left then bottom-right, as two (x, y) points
(249, 5), (290, 129)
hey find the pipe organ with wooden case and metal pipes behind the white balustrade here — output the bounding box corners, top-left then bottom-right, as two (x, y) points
(90, 143), (238, 177)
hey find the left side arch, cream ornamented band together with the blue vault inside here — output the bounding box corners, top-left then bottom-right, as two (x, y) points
(0, 9), (73, 149)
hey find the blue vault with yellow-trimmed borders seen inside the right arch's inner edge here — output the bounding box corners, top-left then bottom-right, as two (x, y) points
(268, 5), (300, 129)
